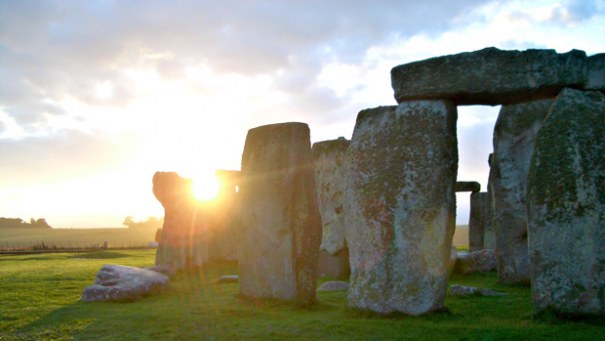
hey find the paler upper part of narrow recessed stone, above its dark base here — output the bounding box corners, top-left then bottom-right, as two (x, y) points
(313, 137), (350, 255)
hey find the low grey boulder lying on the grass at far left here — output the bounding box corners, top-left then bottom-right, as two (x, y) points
(82, 265), (170, 302)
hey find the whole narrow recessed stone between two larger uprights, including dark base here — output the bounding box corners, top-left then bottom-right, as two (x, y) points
(313, 137), (350, 278)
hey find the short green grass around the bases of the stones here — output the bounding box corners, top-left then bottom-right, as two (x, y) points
(0, 250), (605, 340)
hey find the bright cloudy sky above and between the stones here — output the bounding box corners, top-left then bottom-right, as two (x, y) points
(0, 0), (605, 227)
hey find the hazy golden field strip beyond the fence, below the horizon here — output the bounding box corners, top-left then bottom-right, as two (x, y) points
(0, 227), (155, 250)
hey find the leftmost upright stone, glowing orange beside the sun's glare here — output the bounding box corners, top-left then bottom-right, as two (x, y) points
(153, 172), (208, 270)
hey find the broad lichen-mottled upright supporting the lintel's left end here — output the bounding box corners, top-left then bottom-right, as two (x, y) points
(345, 101), (458, 315)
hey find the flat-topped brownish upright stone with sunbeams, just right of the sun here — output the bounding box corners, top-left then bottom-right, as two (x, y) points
(238, 123), (321, 303)
